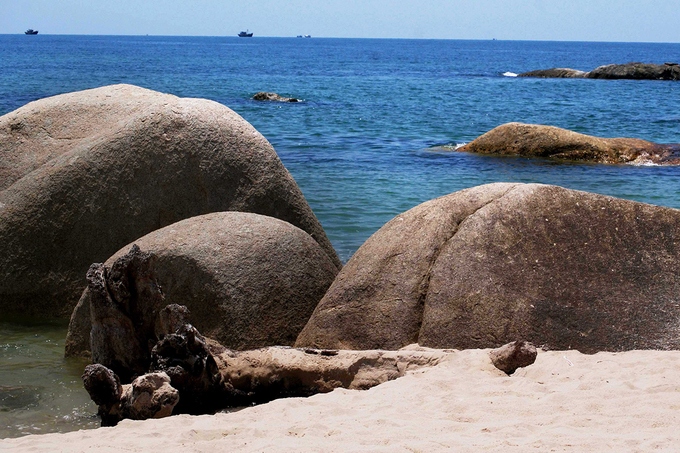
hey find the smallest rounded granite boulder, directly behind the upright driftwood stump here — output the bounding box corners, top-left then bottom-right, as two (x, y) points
(66, 212), (338, 356)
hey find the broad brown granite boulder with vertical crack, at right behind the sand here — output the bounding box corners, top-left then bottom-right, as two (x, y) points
(296, 183), (680, 353)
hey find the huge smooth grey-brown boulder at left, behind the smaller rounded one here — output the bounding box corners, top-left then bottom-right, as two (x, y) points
(0, 85), (341, 317)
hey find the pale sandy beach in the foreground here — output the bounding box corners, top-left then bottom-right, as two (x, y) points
(0, 350), (680, 453)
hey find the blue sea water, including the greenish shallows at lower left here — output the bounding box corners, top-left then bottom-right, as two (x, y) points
(0, 35), (680, 437)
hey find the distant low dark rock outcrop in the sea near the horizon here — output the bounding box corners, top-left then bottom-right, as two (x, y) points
(518, 62), (680, 80)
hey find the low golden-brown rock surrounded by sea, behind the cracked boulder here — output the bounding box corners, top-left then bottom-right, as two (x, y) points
(457, 123), (680, 165)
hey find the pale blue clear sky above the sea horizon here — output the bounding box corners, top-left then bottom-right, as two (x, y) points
(0, 0), (680, 42)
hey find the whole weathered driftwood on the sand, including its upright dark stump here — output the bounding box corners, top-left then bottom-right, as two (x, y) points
(83, 246), (446, 425)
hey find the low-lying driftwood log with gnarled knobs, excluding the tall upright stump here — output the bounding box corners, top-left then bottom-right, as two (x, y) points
(83, 306), (446, 426)
